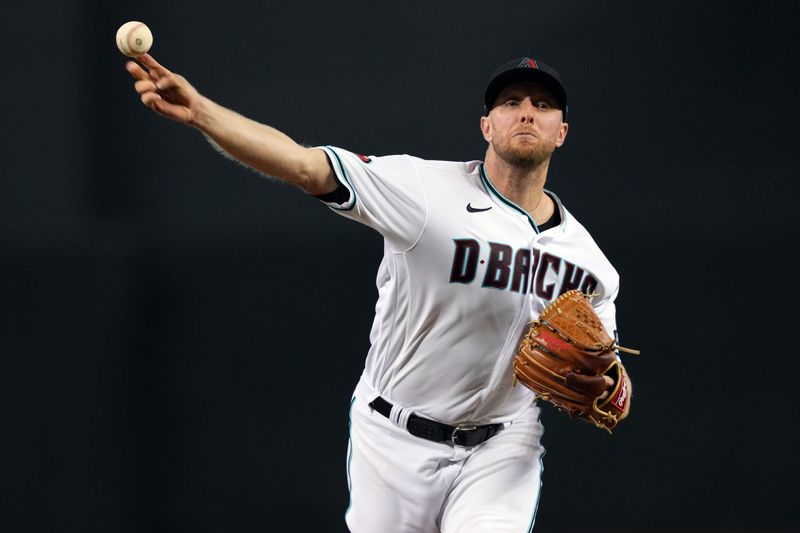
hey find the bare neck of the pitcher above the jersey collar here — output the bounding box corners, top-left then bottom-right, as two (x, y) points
(485, 150), (554, 224)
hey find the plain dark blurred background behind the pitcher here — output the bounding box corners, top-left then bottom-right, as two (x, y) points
(0, 0), (800, 533)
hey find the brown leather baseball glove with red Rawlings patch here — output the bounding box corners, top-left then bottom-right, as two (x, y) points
(514, 290), (639, 433)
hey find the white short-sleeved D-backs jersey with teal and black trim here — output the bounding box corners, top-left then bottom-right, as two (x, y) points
(322, 147), (619, 424)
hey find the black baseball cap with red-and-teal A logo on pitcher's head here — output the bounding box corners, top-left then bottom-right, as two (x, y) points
(483, 57), (567, 122)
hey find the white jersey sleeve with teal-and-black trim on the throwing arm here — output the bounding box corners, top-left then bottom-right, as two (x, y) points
(320, 146), (427, 251)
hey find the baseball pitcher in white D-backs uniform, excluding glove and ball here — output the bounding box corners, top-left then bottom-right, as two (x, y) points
(126, 54), (630, 533)
